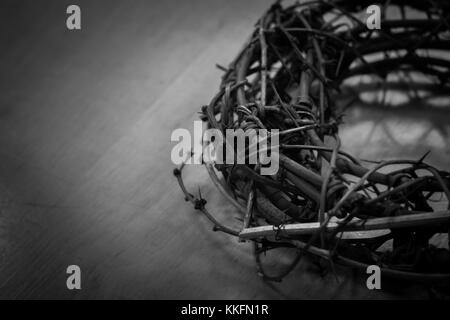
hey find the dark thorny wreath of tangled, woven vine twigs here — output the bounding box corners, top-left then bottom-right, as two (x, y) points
(174, 0), (450, 283)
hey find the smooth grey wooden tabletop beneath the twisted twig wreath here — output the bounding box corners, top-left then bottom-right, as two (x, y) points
(0, 0), (450, 299)
